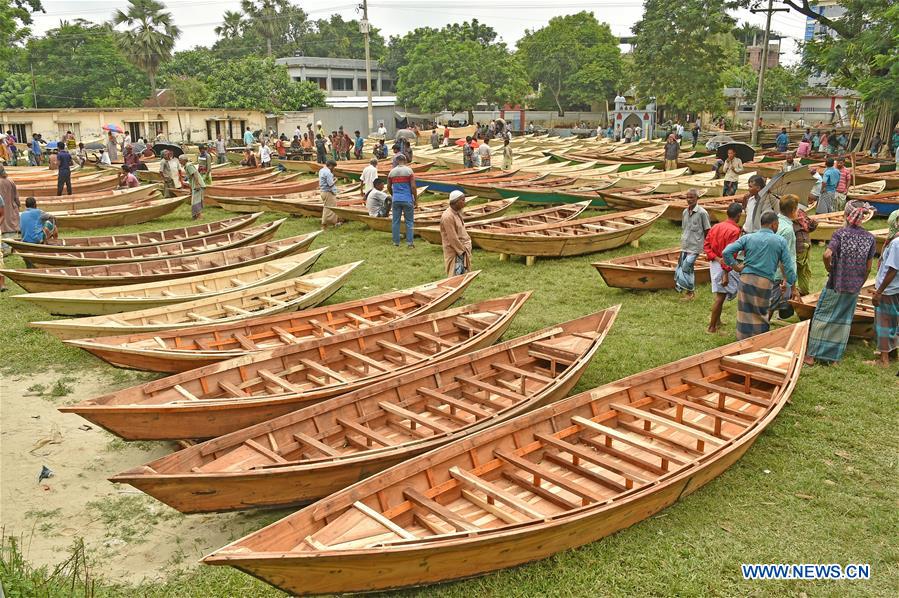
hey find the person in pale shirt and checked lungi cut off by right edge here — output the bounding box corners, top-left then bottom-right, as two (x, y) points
(873, 210), (899, 367)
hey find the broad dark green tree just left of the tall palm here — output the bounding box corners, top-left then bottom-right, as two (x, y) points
(23, 20), (148, 108)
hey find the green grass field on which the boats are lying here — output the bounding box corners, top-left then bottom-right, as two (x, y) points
(0, 196), (899, 597)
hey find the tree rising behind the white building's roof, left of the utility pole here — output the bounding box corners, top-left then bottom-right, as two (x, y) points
(298, 14), (385, 60)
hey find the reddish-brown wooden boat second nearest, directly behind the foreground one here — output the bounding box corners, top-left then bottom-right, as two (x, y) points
(111, 306), (620, 513)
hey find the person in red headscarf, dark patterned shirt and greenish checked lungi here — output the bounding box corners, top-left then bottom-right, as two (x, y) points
(805, 201), (876, 365)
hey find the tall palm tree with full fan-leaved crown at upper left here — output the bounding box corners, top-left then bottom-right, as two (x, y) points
(112, 0), (181, 102)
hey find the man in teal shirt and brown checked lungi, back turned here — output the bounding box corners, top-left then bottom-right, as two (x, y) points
(724, 210), (796, 340)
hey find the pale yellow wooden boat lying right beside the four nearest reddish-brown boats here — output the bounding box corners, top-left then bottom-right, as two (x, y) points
(29, 262), (362, 342)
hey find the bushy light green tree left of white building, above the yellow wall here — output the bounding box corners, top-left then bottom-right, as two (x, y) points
(205, 56), (325, 112)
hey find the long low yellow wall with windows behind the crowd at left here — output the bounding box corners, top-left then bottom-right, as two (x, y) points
(0, 108), (265, 143)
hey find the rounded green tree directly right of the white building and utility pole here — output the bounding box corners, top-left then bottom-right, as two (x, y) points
(397, 24), (530, 112)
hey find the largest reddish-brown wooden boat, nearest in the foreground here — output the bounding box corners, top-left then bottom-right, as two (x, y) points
(203, 323), (808, 595)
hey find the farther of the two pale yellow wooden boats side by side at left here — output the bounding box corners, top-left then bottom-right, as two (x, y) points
(13, 249), (325, 316)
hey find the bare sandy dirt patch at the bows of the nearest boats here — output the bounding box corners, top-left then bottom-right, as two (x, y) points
(0, 373), (274, 583)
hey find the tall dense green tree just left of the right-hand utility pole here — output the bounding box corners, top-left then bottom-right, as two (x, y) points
(633, 0), (740, 112)
